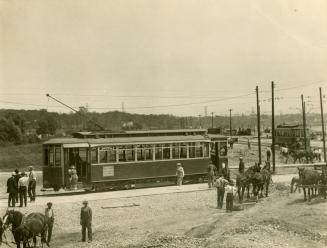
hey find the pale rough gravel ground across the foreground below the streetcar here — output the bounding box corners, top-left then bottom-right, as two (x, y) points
(0, 184), (327, 248)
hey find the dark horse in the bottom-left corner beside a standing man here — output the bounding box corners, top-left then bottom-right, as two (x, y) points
(4, 210), (48, 248)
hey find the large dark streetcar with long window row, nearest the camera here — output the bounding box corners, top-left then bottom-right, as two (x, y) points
(43, 129), (227, 191)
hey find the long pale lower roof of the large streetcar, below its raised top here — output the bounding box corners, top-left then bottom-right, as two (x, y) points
(43, 135), (210, 147)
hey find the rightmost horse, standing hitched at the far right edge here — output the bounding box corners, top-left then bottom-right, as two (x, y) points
(298, 168), (320, 201)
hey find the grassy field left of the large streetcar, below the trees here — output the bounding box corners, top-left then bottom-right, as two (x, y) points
(0, 143), (42, 171)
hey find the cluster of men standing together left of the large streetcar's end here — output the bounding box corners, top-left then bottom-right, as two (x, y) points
(7, 166), (36, 207)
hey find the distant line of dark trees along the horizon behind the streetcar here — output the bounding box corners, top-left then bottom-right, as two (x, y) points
(0, 107), (320, 146)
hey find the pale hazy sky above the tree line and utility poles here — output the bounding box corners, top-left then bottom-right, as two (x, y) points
(0, 0), (327, 116)
